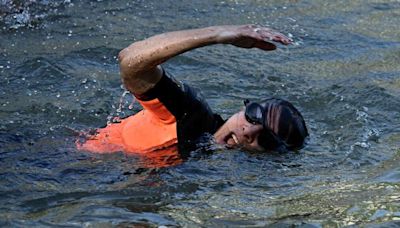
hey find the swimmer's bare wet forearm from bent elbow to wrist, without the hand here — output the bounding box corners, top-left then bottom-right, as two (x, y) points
(119, 27), (219, 93)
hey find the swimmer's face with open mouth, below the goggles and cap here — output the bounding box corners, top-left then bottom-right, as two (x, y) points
(214, 110), (265, 151)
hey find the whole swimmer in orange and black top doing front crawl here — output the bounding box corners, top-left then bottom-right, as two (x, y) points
(77, 25), (308, 154)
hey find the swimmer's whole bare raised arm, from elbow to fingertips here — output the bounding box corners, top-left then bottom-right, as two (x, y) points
(119, 25), (292, 94)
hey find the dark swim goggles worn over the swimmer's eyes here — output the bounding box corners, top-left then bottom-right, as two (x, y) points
(243, 99), (290, 152)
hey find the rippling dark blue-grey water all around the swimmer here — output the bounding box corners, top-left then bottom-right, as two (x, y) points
(0, 0), (400, 227)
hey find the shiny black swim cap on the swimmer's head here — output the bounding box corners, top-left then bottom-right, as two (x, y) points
(258, 98), (308, 151)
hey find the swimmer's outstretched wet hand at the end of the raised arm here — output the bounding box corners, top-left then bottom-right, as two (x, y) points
(218, 25), (293, 51)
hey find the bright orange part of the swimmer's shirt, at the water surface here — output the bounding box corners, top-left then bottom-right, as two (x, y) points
(76, 98), (178, 153)
